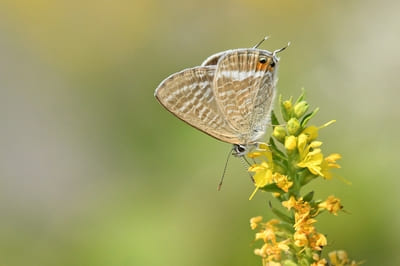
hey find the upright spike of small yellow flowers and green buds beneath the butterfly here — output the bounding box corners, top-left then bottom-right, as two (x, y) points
(248, 92), (358, 266)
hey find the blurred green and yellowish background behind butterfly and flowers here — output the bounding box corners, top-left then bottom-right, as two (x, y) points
(0, 0), (400, 266)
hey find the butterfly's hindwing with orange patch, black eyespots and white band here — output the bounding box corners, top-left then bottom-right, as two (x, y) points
(212, 49), (276, 144)
